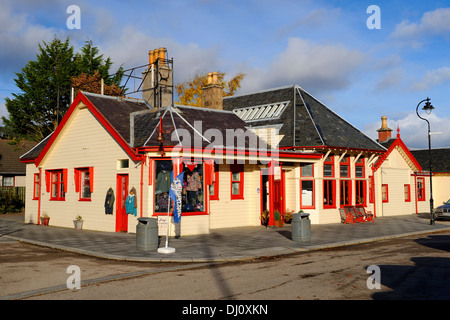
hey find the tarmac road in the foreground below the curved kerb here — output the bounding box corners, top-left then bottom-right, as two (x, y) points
(0, 231), (450, 304)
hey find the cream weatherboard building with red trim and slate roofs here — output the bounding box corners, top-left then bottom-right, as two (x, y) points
(21, 48), (438, 235)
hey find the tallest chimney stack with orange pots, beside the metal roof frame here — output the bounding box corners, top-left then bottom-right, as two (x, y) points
(142, 48), (173, 107)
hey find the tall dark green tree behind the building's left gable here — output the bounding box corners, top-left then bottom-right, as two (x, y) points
(2, 38), (123, 141)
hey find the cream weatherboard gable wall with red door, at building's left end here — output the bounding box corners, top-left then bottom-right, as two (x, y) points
(25, 104), (143, 232)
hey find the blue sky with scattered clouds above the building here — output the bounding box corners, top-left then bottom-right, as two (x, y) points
(0, 0), (450, 149)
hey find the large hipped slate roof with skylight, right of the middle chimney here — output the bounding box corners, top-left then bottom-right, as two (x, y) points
(223, 85), (385, 151)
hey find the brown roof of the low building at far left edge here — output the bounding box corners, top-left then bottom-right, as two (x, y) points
(0, 140), (37, 175)
